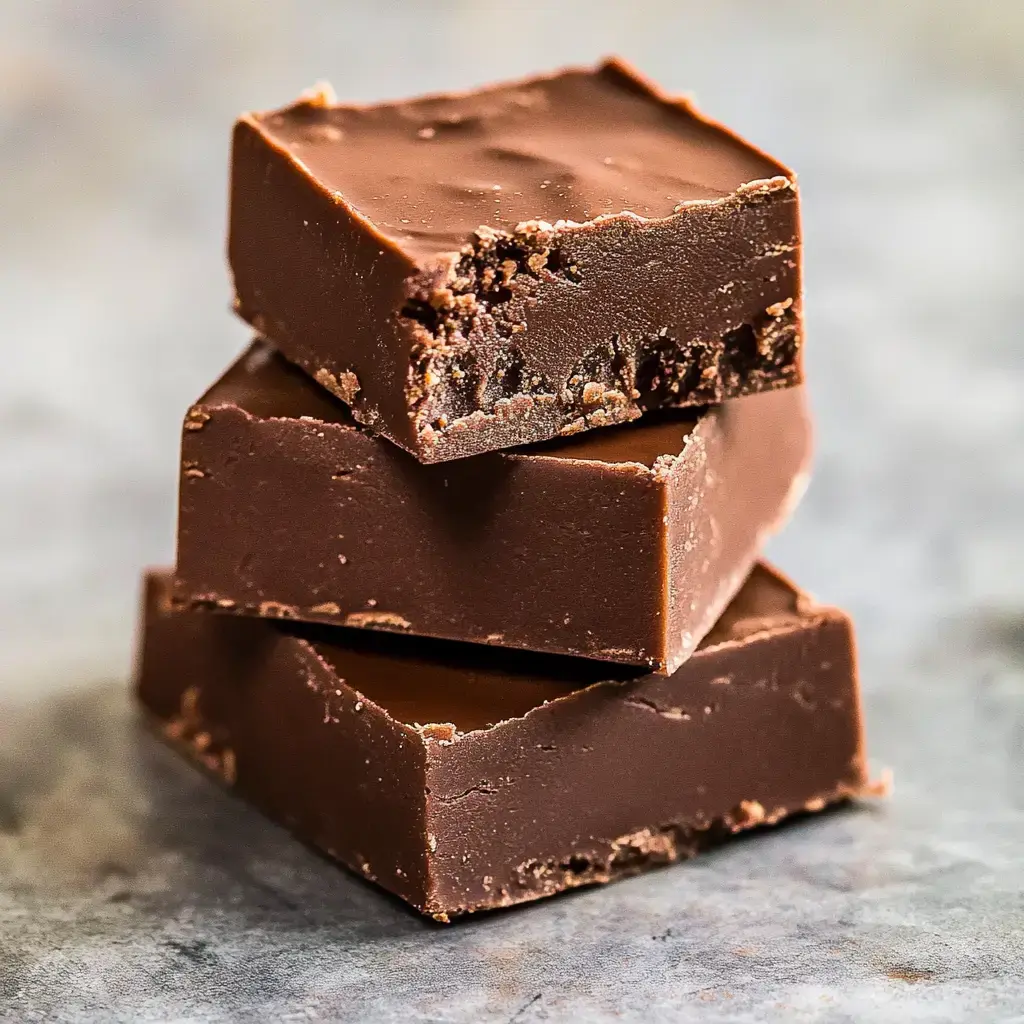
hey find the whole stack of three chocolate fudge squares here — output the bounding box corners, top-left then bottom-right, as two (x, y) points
(136, 60), (867, 921)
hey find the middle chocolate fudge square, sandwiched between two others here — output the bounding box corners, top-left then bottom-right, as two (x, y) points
(175, 342), (810, 673)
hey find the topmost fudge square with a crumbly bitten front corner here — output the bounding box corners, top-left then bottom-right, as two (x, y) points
(228, 59), (802, 462)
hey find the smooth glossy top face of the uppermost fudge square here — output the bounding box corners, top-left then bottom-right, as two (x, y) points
(249, 61), (787, 257)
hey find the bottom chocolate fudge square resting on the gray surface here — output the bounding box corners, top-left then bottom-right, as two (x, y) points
(137, 563), (866, 922)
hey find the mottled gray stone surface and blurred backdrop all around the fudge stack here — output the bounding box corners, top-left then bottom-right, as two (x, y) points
(0, 0), (1024, 1024)
